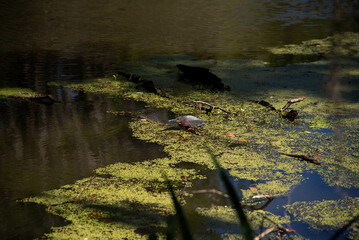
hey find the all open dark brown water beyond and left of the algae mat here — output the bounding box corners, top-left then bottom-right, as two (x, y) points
(0, 0), (358, 239)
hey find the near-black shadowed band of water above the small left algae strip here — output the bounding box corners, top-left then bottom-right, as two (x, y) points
(0, 51), (110, 94)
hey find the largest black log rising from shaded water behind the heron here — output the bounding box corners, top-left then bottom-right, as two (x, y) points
(177, 64), (231, 91)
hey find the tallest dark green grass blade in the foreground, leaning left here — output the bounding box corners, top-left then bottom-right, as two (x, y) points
(208, 149), (254, 240)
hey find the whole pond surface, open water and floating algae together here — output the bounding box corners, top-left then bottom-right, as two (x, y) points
(0, 1), (359, 239)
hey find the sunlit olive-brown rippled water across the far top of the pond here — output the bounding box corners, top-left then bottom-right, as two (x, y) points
(0, 0), (357, 61)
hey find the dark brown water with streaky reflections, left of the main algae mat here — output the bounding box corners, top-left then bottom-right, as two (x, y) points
(0, 88), (167, 239)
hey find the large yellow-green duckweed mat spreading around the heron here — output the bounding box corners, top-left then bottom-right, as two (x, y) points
(24, 33), (359, 239)
